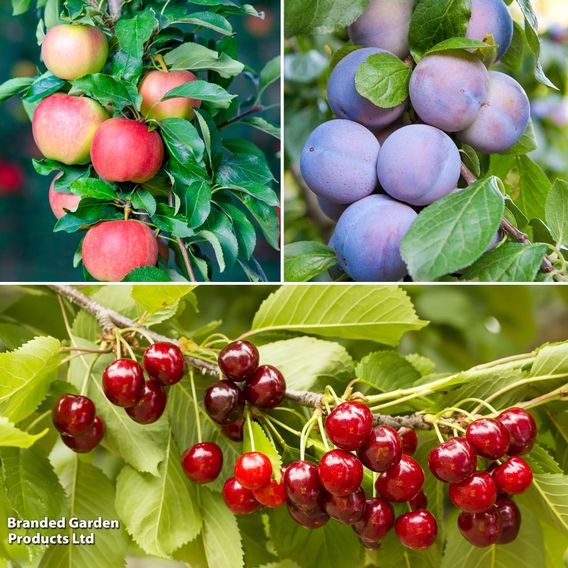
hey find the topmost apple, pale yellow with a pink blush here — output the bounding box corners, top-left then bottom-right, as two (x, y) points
(41, 24), (108, 81)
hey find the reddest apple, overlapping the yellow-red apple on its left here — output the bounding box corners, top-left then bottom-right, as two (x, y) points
(91, 118), (164, 183)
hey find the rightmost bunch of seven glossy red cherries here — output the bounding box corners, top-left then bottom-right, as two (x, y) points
(428, 408), (537, 547)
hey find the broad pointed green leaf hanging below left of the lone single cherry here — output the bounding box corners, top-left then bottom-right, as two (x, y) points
(116, 435), (201, 558)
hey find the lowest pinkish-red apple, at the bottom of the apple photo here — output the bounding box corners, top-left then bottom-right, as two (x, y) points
(82, 221), (158, 282)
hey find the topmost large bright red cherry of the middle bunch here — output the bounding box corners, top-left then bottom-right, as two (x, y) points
(325, 402), (373, 452)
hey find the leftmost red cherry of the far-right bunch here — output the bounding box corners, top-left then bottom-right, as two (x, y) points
(428, 438), (477, 483)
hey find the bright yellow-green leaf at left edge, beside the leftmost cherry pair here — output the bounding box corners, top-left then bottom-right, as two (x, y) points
(0, 337), (61, 423)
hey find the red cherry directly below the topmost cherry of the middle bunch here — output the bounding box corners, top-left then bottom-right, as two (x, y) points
(318, 450), (363, 497)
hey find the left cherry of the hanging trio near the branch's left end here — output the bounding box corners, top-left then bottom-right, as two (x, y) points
(103, 359), (144, 408)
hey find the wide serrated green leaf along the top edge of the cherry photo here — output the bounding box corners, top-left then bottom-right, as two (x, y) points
(252, 285), (426, 345)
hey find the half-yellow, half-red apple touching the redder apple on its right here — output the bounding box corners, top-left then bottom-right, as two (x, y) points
(32, 93), (108, 165)
